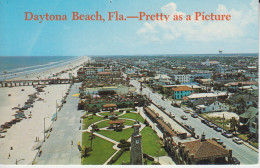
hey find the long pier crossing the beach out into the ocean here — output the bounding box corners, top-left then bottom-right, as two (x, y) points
(0, 79), (73, 87)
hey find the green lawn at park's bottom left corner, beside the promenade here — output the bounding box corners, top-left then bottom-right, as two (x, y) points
(81, 132), (115, 165)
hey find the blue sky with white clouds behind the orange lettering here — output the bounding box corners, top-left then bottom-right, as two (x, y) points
(0, 0), (258, 56)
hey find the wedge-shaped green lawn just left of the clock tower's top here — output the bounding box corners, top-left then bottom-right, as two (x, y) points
(97, 128), (134, 142)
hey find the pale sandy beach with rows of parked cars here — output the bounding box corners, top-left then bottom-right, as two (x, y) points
(0, 57), (88, 165)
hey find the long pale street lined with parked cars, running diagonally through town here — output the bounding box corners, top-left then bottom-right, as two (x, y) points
(130, 80), (258, 164)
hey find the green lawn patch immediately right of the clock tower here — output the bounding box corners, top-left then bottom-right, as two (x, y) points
(141, 127), (168, 157)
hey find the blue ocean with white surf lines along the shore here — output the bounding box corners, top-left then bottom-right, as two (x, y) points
(0, 56), (78, 80)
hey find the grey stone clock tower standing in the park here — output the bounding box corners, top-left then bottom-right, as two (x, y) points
(130, 122), (143, 165)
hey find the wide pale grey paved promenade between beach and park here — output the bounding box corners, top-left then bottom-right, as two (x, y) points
(36, 84), (82, 165)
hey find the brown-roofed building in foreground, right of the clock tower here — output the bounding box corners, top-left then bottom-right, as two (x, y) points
(164, 134), (232, 165)
